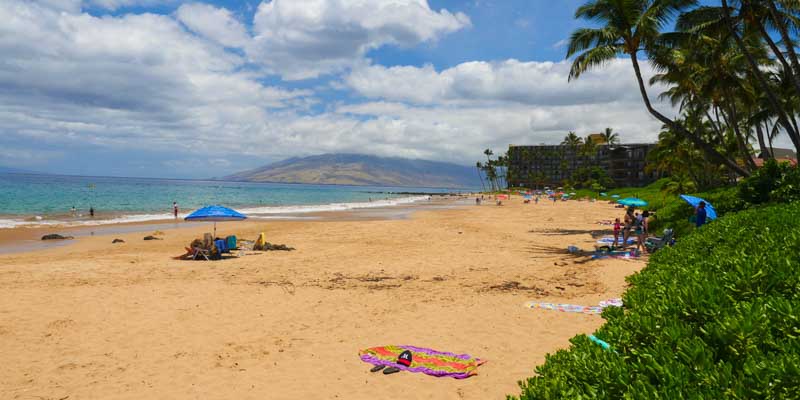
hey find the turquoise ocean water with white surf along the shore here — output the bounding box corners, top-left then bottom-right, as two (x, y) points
(0, 174), (468, 228)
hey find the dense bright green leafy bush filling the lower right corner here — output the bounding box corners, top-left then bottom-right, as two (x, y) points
(519, 203), (800, 399)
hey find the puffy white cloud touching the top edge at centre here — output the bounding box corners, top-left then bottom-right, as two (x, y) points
(247, 0), (470, 79)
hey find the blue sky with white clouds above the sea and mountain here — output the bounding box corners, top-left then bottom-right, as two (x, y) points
(0, 0), (748, 178)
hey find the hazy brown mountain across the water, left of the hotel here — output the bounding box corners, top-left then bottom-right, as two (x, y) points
(224, 154), (481, 188)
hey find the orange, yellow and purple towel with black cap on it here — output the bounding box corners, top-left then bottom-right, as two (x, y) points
(358, 345), (486, 379)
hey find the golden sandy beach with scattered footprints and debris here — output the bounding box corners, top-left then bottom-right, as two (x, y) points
(0, 197), (644, 400)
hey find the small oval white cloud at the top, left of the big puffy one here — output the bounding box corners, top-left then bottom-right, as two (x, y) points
(176, 3), (250, 47)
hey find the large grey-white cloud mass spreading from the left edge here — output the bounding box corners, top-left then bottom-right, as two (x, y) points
(0, 1), (310, 158)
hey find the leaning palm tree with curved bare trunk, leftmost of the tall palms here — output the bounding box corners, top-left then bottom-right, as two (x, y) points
(567, 0), (750, 176)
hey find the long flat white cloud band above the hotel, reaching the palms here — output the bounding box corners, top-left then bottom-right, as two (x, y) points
(346, 59), (660, 106)
